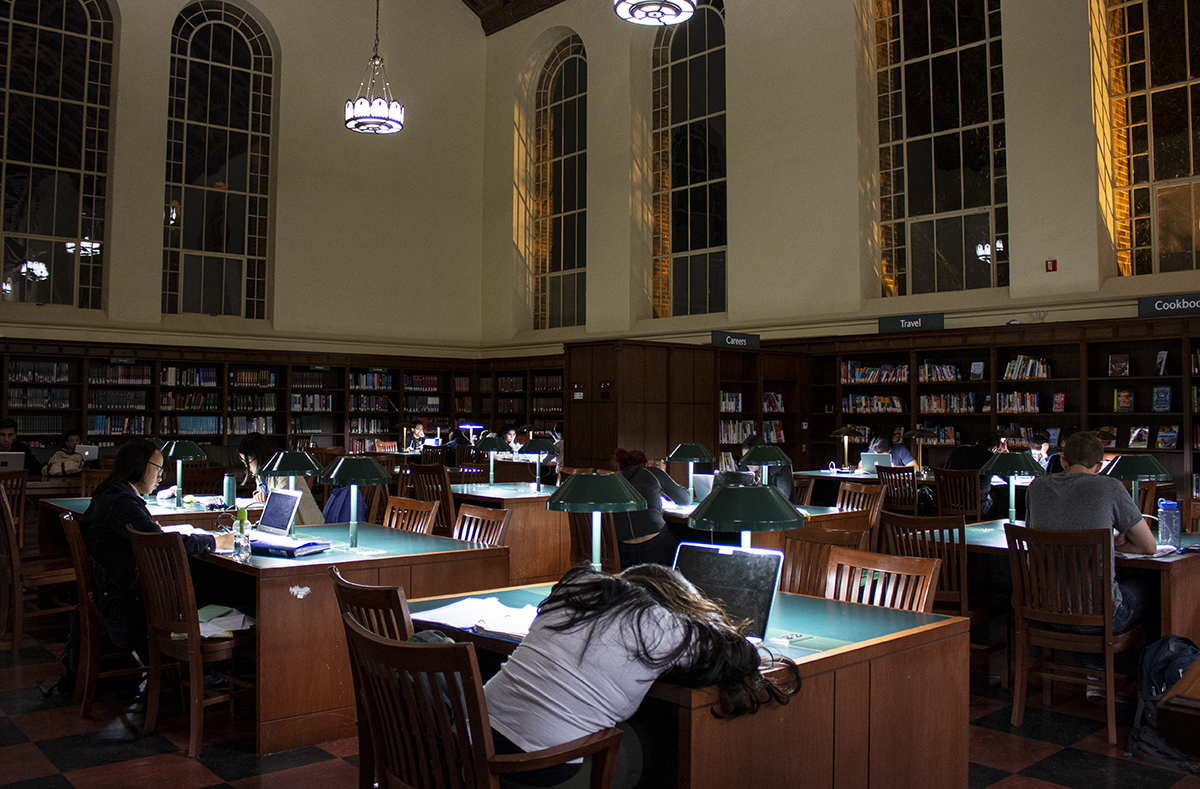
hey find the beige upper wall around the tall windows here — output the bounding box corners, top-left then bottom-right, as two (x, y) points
(0, 0), (1200, 356)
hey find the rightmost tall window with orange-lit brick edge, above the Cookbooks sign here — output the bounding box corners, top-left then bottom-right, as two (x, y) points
(1108, 0), (1200, 277)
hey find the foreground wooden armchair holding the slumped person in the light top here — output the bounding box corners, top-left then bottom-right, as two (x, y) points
(342, 614), (620, 789)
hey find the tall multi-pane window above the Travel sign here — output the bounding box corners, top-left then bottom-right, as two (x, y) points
(875, 0), (1009, 296)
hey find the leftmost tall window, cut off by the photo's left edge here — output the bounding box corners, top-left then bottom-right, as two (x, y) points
(0, 0), (113, 309)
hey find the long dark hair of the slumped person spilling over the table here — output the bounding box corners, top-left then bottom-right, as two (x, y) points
(538, 565), (800, 718)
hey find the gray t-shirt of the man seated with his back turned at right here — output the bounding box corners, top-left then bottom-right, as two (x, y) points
(1025, 474), (1141, 606)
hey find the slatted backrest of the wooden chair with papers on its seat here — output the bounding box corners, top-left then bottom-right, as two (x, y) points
(125, 522), (200, 637)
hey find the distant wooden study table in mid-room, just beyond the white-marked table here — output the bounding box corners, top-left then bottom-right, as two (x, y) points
(450, 482), (571, 584)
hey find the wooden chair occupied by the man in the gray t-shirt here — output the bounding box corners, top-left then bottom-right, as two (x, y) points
(1004, 523), (1146, 745)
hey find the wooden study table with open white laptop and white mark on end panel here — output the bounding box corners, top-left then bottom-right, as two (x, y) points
(192, 523), (509, 753)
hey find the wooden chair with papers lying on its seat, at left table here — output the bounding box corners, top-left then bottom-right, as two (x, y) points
(126, 526), (256, 758)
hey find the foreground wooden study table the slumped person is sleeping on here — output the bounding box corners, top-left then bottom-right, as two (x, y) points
(409, 585), (970, 789)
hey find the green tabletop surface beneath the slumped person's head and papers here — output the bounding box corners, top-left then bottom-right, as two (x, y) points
(408, 584), (948, 659)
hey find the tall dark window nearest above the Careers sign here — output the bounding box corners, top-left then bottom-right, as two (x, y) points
(650, 0), (727, 318)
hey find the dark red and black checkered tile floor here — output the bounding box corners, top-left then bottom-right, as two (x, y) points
(0, 631), (1200, 789)
